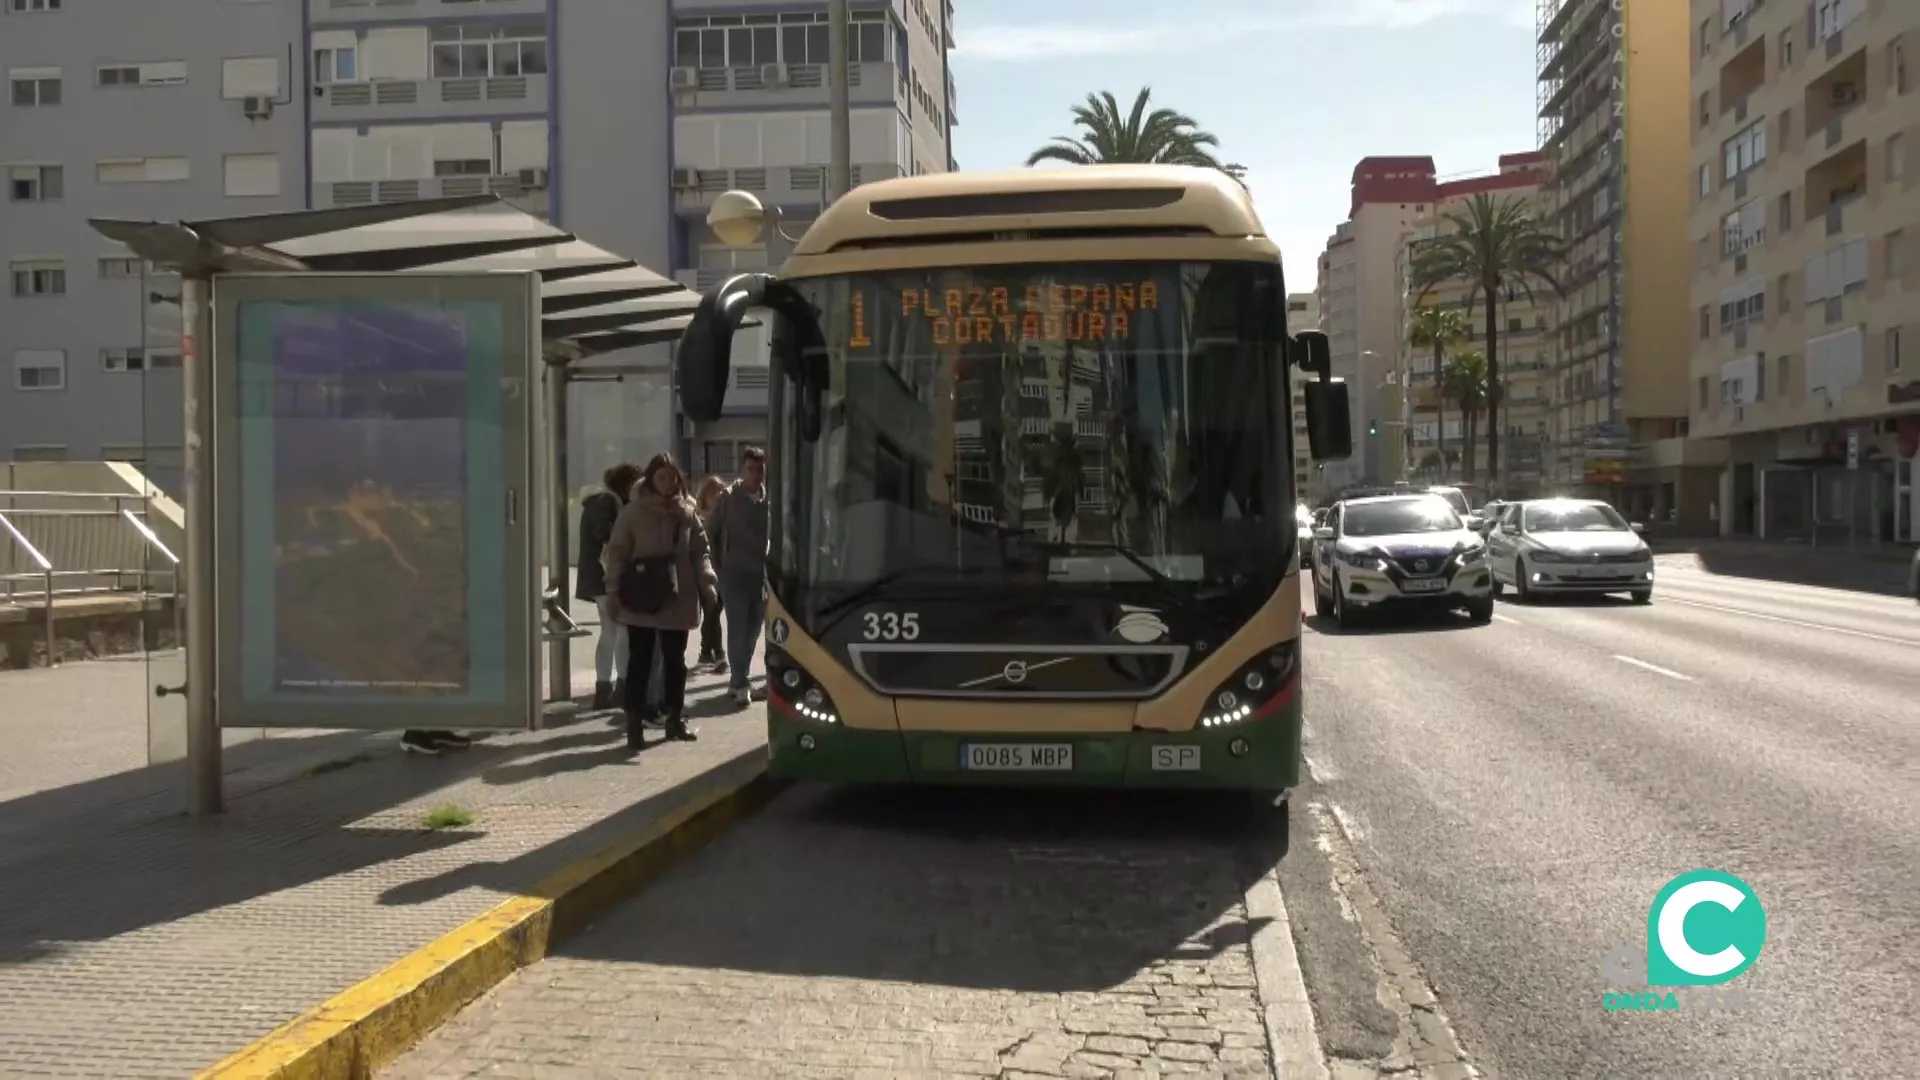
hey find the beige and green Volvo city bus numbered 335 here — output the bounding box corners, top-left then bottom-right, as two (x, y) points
(676, 165), (1352, 813)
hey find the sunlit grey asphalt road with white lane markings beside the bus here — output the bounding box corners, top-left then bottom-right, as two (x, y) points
(1281, 553), (1920, 1078)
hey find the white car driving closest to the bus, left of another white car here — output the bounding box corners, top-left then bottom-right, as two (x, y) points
(1313, 494), (1494, 626)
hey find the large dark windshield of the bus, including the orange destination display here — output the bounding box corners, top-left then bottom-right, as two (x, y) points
(772, 261), (1296, 594)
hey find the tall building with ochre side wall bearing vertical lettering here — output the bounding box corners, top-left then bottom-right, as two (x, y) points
(1536, 0), (1704, 530)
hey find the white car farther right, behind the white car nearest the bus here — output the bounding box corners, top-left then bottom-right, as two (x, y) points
(1486, 500), (1653, 603)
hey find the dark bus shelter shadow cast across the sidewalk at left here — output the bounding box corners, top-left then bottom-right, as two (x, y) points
(0, 732), (599, 965)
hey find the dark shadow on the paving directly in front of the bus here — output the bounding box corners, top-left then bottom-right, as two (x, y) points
(559, 786), (1284, 994)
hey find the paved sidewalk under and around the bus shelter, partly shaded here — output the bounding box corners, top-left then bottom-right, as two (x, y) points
(0, 618), (766, 1078)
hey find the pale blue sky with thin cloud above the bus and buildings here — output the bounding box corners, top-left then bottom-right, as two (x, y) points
(952, 0), (1551, 292)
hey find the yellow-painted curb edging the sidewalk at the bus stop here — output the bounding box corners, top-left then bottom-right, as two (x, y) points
(198, 765), (783, 1080)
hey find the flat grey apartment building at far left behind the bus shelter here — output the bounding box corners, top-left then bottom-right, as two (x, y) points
(0, 0), (307, 484)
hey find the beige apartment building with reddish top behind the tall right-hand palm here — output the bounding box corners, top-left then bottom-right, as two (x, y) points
(1396, 150), (1553, 498)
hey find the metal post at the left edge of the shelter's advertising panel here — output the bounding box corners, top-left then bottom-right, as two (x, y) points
(179, 271), (225, 817)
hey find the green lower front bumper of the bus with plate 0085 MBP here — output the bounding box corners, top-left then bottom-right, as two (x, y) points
(766, 698), (1300, 794)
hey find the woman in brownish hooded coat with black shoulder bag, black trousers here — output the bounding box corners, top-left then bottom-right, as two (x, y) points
(603, 454), (716, 749)
